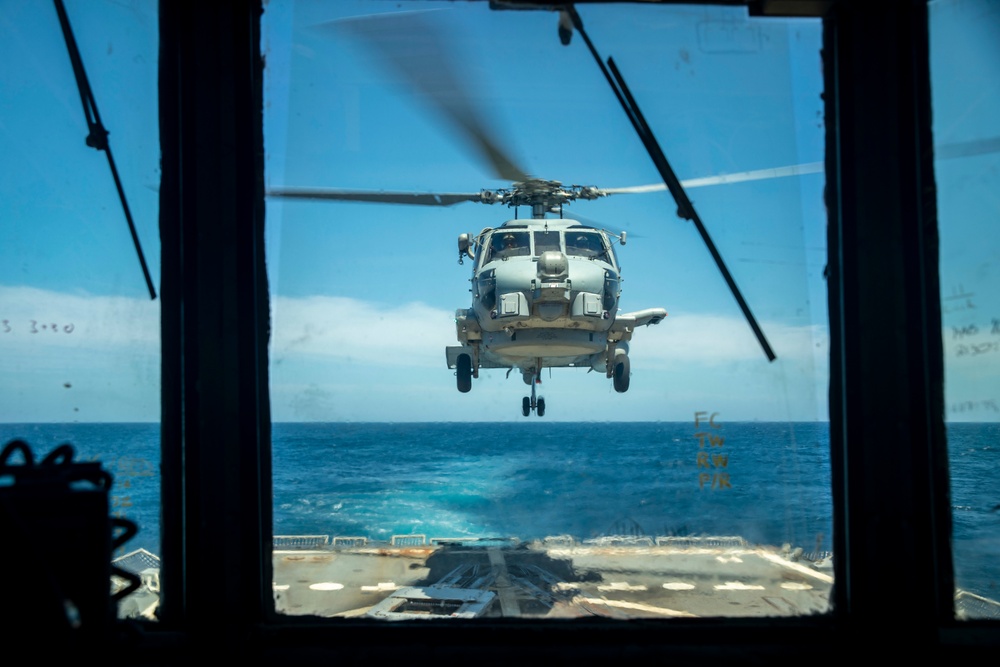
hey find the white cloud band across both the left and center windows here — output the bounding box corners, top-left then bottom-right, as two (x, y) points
(0, 287), (829, 421)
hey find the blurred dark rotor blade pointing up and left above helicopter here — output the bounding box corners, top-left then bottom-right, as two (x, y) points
(332, 12), (529, 181)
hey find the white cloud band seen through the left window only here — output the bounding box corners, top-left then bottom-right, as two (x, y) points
(0, 286), (160, 422)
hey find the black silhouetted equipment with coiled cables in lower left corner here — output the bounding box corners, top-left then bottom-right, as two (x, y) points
(0, 440), (139, 652)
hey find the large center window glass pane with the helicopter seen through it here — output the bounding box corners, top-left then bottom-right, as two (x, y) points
(263, 0), (832, 620)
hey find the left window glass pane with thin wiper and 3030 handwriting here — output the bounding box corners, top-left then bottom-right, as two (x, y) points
(0, 0), (160, 619)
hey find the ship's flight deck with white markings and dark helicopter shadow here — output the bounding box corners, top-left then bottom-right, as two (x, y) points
(113, 535), (833, 622)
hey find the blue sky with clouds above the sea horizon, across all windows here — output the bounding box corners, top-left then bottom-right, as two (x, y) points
(0, 0), (1000, 422)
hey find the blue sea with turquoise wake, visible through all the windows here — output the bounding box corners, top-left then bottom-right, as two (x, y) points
(0, 420), (1000, 599)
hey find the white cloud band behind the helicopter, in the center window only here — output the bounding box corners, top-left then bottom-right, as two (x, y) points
(271, 297), (829, 421)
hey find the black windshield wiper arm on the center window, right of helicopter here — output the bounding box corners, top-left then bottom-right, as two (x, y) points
(560, 5), (776, 361)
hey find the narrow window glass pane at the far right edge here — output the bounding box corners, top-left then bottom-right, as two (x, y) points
(929, 0), (1000, 618)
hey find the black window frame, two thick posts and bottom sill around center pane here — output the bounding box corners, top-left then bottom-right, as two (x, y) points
(150, 0), (1000, 664)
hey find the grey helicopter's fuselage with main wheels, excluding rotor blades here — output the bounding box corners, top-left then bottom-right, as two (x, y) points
(447, 219), (666, 412)
